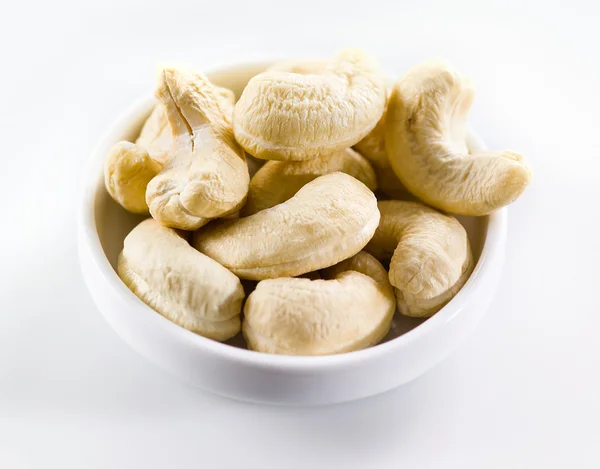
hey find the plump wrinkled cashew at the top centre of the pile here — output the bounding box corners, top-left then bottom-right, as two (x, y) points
(233, 49), (386, 160)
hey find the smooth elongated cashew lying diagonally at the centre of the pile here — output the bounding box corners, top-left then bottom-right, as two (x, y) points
(194, 173), (379, 280)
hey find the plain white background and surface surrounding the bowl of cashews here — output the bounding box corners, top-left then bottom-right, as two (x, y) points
(0, 0), (600, 469)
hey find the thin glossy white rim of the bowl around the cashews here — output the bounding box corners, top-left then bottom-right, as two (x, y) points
(77, 60), (507, 372)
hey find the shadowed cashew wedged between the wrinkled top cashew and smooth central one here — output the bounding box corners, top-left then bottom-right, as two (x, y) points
(242, 148), (377, 216)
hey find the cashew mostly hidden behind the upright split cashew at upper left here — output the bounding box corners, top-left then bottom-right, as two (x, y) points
(135, 86), (235, 165)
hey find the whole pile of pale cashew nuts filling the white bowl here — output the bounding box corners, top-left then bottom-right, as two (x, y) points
(105, 49), (531, 355)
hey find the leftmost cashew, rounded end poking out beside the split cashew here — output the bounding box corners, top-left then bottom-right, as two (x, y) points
(104, 142), (161, 214)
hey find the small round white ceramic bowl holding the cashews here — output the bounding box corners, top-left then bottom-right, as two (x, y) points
(78, 63), (506, 405)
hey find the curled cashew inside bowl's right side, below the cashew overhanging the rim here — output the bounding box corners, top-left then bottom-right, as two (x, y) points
(365, 200), (473, 317)
